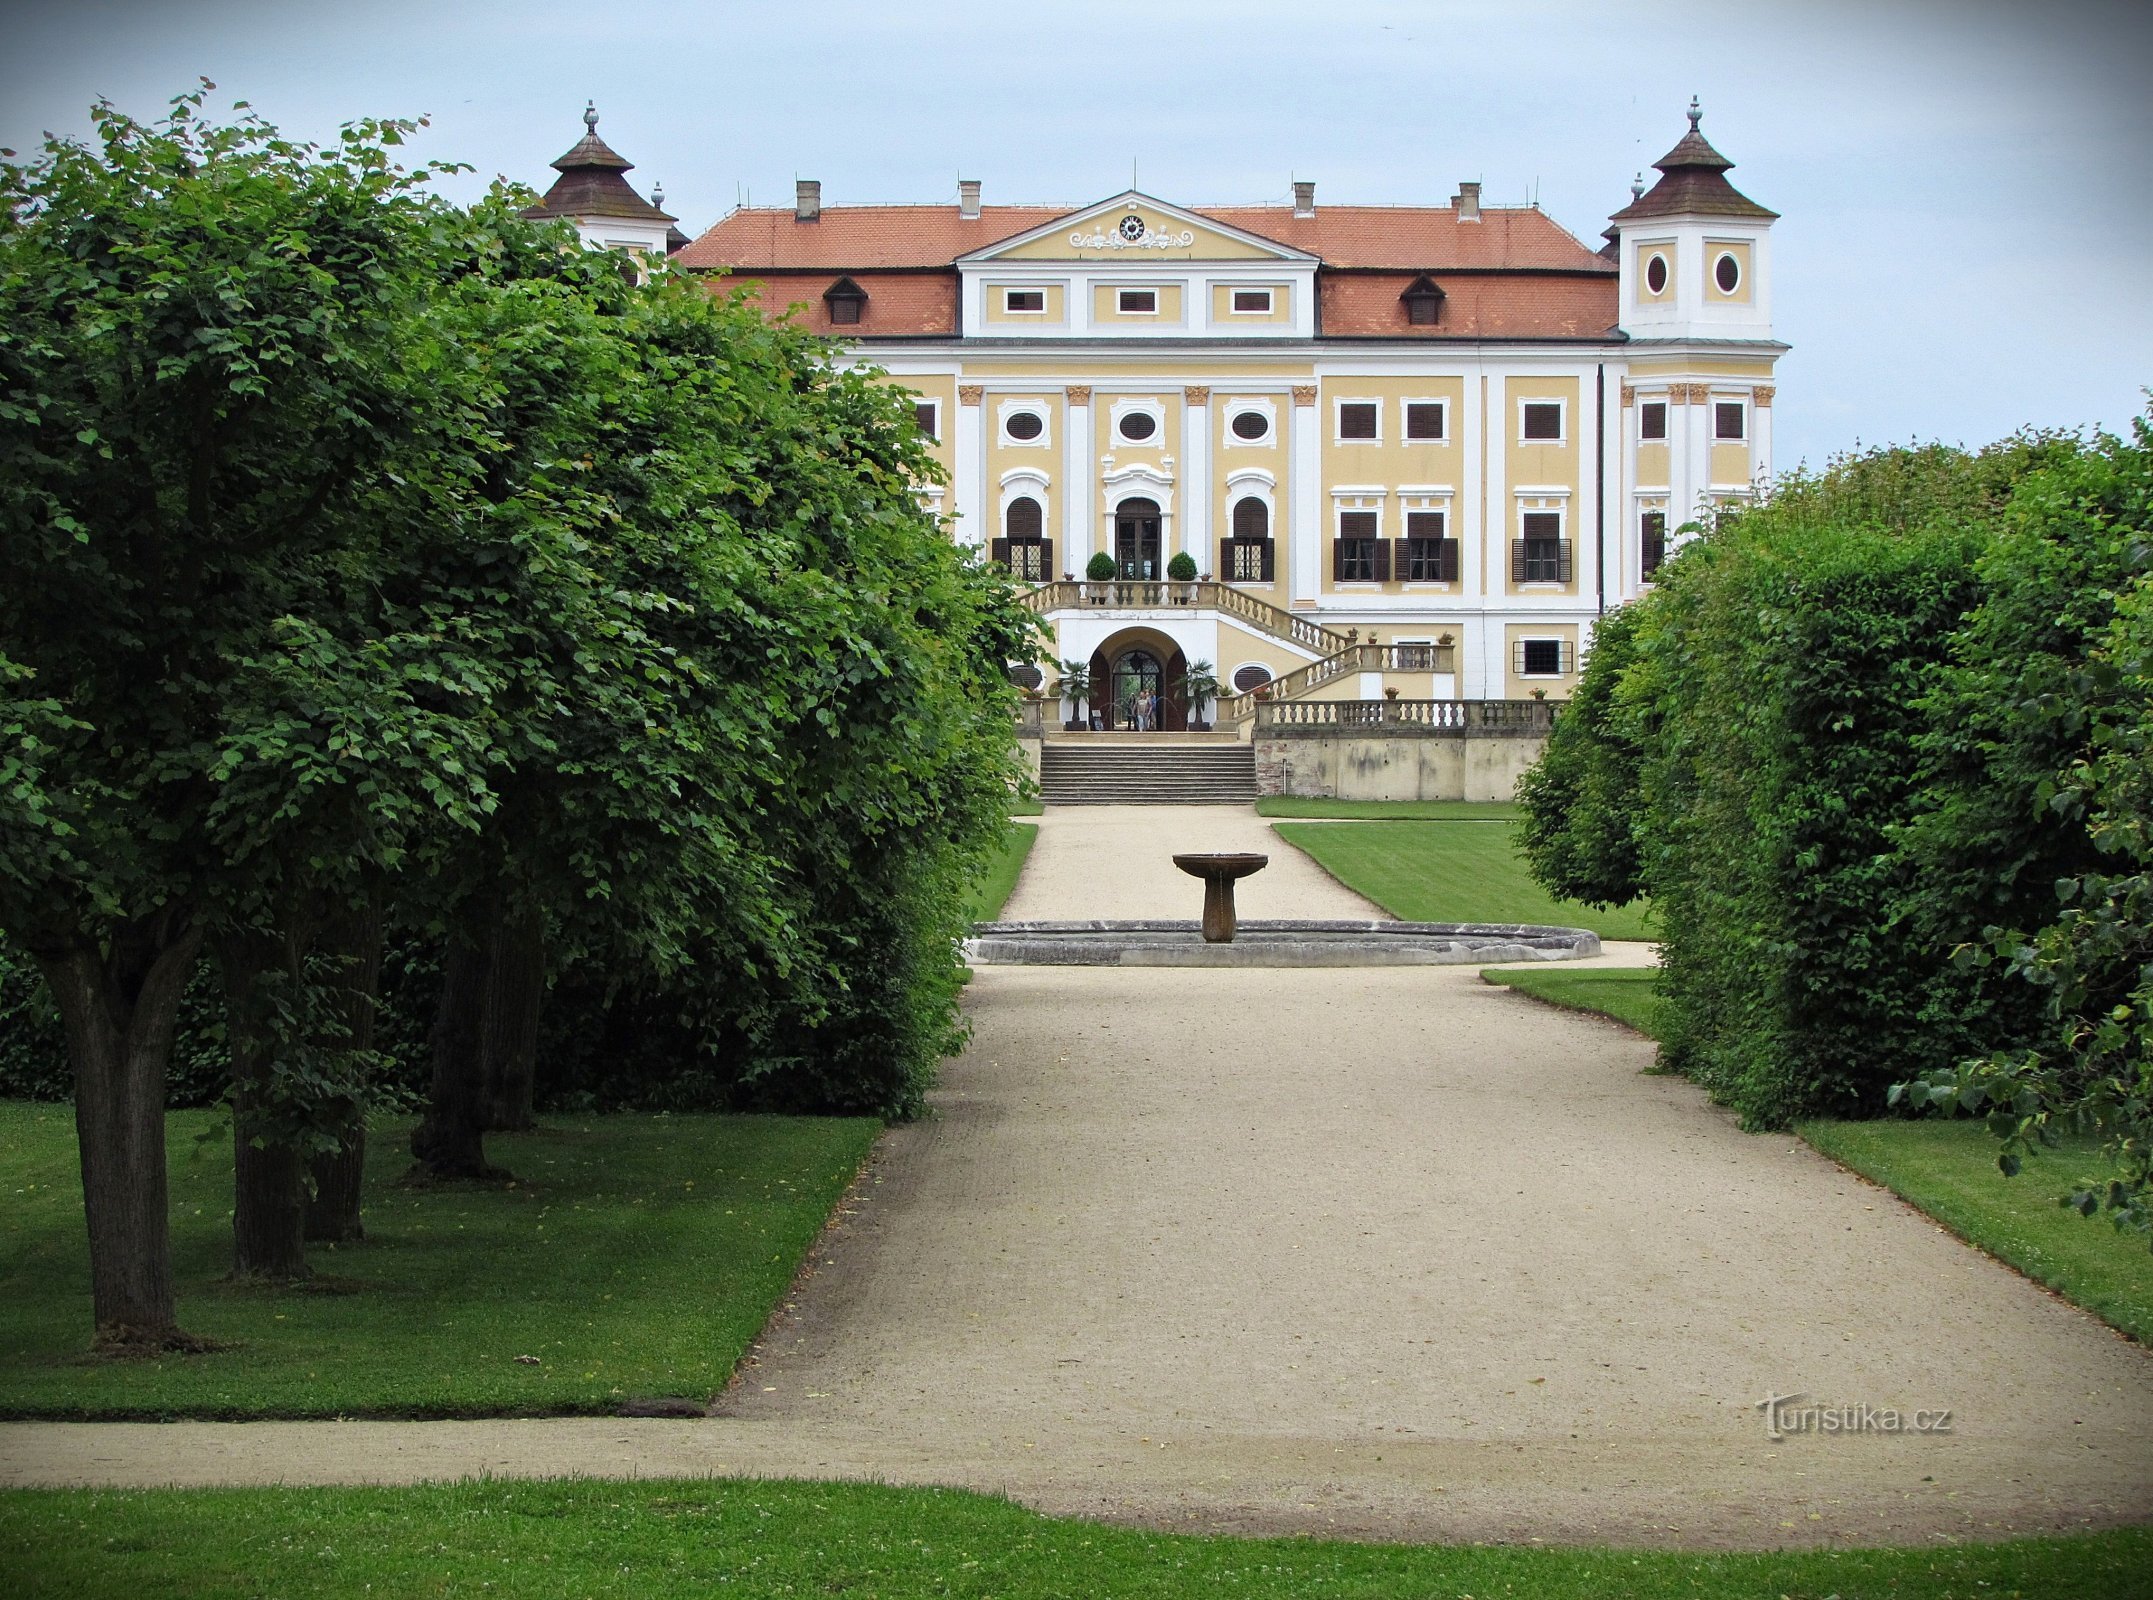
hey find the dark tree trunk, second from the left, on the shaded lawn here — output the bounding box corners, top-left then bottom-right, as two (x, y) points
(217, 937), (306, 1279)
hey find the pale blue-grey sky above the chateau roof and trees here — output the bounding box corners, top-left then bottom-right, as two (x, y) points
(0, 0), (2153, 467)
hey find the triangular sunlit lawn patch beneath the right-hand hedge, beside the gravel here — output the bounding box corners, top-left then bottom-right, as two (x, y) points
(1798, 1118), (2153, 1344)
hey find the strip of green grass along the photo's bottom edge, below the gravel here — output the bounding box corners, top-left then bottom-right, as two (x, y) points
(0, 1479), (2153, 1600)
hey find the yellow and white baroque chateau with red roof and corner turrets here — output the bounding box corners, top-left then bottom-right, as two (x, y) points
(534, 101), (1787, 758)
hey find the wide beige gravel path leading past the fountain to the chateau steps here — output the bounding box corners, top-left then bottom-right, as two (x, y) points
(0, 812), (2153, 1546)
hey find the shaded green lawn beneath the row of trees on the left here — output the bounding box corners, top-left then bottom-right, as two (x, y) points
(0, 1103), (881, 1417)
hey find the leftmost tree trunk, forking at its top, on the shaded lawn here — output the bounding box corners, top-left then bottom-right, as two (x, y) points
(32, 911), (202, 1350)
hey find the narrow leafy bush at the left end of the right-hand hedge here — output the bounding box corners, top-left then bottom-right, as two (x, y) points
(1518, 609), (1645, 907)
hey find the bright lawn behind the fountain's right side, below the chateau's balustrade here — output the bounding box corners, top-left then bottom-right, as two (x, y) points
(1272, 820), (1654, 939)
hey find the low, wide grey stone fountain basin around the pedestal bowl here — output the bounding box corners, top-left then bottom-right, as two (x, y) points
(965, 920), (1600, 967)
